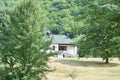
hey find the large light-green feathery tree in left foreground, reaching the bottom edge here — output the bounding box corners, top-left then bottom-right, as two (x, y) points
(0, 0), (51, 80)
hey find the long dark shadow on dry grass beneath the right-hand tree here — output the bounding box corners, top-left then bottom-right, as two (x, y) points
(54, 59), (120, 67)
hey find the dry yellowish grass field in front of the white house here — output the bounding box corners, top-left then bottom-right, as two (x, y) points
(47, 58), (120, 80)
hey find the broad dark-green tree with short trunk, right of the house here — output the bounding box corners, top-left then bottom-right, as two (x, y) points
(78, 0), (120, 63)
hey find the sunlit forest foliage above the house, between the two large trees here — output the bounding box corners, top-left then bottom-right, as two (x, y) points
(42, 0), (82, 38)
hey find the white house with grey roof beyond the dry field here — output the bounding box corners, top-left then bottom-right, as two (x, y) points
(47, 33), (77, 57)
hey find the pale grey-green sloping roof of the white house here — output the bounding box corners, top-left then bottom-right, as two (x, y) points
(51, 35), (75, 45)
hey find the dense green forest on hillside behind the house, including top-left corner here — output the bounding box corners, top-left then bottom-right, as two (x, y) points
(0, 0), (119, 38)
